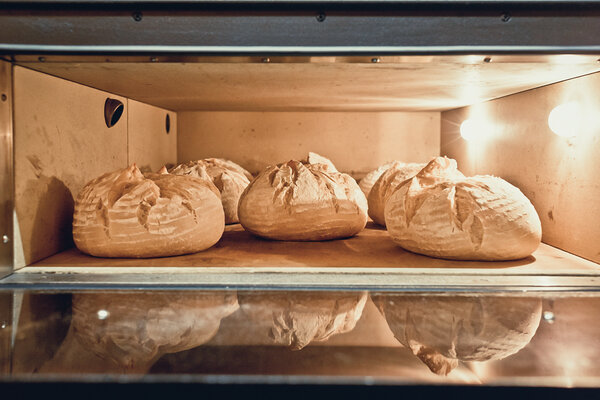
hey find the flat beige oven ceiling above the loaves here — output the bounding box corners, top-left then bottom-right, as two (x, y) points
(16, 55), (600, 111)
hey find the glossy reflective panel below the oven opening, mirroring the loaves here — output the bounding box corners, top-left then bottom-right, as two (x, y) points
(9, 290), (600, 385)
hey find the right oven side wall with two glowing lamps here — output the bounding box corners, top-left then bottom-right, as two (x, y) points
(441, 73), (600, 262)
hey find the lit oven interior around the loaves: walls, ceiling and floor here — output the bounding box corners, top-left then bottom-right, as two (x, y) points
(2, 54), (600, 286)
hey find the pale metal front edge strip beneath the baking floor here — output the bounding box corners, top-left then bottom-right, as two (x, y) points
(0, 269), (600, 294)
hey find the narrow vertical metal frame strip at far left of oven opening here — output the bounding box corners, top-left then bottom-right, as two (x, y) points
(0, 61), (14, 277)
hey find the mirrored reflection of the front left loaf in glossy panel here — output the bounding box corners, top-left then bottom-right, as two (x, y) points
(71, 292), (238, 369)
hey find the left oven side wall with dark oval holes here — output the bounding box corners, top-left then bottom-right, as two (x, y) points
(13, 67), (177, 268)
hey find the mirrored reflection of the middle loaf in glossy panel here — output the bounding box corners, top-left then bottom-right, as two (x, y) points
(239, 292), (367, 350)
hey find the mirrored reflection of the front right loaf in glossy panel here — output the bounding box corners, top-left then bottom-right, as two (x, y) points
(371, 294), (542, 375)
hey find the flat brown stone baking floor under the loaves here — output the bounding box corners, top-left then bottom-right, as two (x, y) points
(32, 222), (598, 275)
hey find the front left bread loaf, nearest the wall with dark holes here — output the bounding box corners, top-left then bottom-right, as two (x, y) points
(73, 164), (225, 258)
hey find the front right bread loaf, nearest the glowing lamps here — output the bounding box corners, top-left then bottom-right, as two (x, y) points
(385, 157), (542, 261)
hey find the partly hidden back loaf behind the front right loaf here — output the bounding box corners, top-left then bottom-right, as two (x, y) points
(367, 161), (427, 226)
